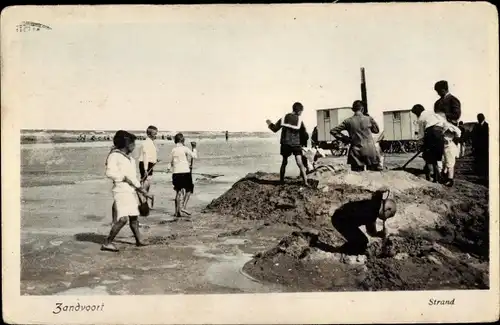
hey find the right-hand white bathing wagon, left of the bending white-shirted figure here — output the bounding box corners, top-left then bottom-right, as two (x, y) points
(380, 110), (418, 152)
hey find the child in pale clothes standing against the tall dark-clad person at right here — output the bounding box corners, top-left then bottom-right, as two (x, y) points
(442, 121), (462, 187)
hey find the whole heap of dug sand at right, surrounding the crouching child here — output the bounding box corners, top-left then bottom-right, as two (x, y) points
(207, 165), (489, 291)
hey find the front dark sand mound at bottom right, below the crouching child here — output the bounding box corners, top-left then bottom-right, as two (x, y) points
(243, 225), (489, 291)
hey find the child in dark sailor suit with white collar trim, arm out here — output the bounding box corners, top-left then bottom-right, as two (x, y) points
(266, 102), (309, 186)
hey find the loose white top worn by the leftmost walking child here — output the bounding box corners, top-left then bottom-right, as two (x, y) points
(106, 151), (141, 193)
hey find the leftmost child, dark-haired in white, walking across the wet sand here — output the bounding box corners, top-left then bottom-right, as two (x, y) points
(101, 130), (149, 252)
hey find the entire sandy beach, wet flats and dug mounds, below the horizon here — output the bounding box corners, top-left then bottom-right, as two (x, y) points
(21, 138), (488, 295)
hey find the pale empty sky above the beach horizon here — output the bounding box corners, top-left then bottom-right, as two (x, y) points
(2, 3), (498, 131)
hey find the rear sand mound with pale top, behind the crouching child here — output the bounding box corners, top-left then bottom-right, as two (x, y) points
(206, 165), (447, 237)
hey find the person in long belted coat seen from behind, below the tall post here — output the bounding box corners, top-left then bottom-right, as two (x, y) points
(330, 100), (380, 171)
